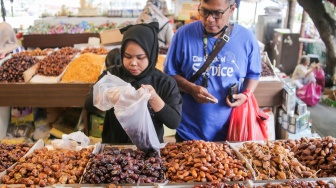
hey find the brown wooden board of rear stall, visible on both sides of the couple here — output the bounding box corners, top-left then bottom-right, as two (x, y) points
(0, 81), (283, 107)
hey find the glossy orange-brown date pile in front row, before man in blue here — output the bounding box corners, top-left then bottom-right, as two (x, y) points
(161, 140), (252, 182)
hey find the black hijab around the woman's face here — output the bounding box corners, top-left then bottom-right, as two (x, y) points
(120, 22), (159, 81)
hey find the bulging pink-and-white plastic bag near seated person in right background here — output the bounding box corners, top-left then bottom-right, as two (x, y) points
(296, 82), (322, 106)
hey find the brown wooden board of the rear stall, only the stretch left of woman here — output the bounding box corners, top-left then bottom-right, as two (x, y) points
(0, 83), (93, 108)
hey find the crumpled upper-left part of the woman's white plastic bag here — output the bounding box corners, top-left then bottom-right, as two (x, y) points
(93, 72), (133, 111)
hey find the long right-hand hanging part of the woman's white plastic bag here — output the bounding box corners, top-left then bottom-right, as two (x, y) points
(114, 88), (163, 151)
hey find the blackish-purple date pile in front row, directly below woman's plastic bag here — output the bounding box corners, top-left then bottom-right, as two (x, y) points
(82, 146), (166, 184)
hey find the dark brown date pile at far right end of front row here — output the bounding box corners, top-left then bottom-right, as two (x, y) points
(279, 136), (336, 177)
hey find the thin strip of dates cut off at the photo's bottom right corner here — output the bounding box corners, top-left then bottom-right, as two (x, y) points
(254, 180), (335, 188)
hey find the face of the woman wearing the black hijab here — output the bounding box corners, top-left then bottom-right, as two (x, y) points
(123, 41), (149, 76)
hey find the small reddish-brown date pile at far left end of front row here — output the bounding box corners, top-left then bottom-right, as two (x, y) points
(0, 144), (33, 172)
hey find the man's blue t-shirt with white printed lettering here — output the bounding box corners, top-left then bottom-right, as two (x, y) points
(164, 21), (261, 141)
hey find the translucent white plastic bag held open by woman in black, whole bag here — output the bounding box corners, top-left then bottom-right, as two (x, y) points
(93, 73), (164, 151)
